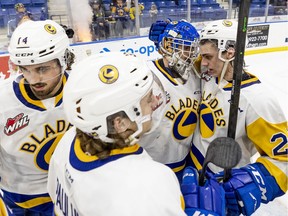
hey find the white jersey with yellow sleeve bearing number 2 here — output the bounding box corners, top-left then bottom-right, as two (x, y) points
(190, 74), (288, 191)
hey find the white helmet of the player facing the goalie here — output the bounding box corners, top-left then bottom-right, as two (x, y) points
(200, 20), (238, 51)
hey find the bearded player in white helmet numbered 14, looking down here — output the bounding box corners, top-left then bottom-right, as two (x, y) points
(0, 20), (71, 216)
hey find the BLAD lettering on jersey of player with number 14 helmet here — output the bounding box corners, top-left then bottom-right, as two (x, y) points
(20, 120), (72, 153)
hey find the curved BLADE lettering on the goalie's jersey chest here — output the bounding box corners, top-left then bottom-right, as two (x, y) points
(165, 98), (199, 120)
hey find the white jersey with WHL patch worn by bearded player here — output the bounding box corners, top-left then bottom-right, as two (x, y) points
(0, 74), (72, 211)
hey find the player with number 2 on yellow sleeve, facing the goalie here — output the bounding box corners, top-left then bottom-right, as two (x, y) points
(187, 20), (288, 215)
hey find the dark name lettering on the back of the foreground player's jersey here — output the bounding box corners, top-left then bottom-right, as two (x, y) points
(55, 178), (79, 216)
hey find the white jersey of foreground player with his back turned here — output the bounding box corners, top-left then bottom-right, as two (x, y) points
(48, 127), (186, 216)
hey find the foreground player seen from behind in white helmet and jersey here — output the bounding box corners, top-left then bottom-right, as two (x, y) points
(48, 52), (185, 216)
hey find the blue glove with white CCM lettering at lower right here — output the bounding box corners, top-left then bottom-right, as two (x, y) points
(215, 163), (283, 215)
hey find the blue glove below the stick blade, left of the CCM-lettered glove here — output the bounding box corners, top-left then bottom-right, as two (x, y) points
(181, 167), (225, 216)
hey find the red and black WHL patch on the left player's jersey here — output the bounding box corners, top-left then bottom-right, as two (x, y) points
(4, 113), (29, 136)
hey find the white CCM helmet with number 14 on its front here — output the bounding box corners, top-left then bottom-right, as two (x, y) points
(8, 20), (69, 66)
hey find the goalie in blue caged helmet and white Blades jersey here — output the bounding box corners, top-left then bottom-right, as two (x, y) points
(139, 20), (201, 181)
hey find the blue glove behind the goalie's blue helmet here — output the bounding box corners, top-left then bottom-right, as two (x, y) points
(149, 19), (174, 49)
